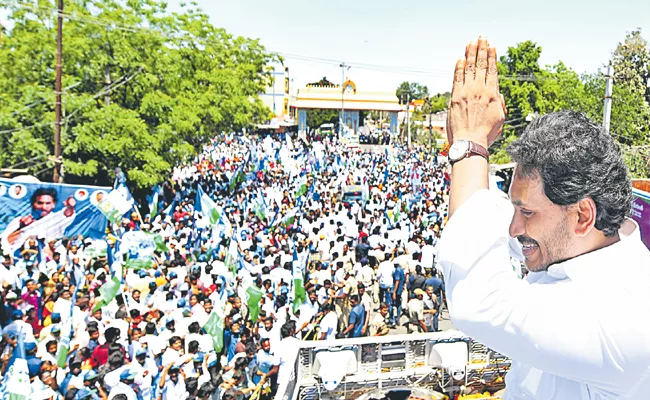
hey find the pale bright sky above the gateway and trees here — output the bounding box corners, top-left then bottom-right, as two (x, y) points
(169, 0), (650, 94)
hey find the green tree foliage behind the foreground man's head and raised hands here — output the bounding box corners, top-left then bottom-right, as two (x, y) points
(491, 30), (650, 177)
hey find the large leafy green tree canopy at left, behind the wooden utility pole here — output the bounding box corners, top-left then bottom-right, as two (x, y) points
(0, 0), (281, 189)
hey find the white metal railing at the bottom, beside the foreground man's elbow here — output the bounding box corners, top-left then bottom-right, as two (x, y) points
(275, 331), (510, 400)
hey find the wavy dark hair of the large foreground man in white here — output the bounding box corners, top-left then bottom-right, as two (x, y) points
(508, 111), (632, 236)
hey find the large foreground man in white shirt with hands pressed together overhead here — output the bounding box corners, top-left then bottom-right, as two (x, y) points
(439, 37), (650, 400)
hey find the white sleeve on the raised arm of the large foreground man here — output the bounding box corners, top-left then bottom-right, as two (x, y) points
(432, 190), (650, 392)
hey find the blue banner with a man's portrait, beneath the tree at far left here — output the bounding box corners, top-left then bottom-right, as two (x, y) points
(0, 179), (112, 253)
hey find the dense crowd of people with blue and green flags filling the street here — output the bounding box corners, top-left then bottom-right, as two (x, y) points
(0, 135), (449, 400)
